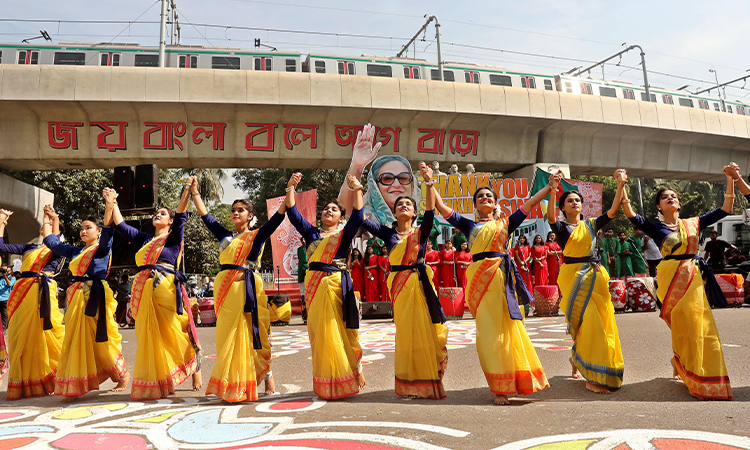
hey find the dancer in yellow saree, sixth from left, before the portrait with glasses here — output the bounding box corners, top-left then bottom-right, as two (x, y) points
(364, 163), (448, 399)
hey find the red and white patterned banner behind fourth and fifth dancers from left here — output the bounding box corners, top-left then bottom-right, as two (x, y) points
(266, 189), (318, 294)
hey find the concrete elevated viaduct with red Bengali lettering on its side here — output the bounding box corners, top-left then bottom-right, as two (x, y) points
(0, 64), (750, 180)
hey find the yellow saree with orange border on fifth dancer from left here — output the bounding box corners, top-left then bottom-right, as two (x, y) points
(305, 229), (362, 399)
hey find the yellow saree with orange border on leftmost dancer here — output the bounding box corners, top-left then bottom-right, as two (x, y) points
(5, 245), (64, 400)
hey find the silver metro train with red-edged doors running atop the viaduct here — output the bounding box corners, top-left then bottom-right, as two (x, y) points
(0, 42), (750, 116)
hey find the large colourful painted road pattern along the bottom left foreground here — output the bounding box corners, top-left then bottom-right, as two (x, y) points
(0, 397), (470, 450)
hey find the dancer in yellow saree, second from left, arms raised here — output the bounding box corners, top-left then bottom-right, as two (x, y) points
(43, 204), (130, 399)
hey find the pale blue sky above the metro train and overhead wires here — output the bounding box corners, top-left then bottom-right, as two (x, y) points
(0, 0), (750, 198)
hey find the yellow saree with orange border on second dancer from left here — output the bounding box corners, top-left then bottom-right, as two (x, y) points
(55, 245), (126, 397)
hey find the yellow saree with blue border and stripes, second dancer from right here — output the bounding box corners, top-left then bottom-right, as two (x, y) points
(557, 219), (625, 388)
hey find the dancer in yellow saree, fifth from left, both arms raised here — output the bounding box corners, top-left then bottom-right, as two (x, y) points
(286, 173), (365, 399)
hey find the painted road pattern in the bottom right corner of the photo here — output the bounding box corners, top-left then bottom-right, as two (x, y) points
(493, 430), (750, 450)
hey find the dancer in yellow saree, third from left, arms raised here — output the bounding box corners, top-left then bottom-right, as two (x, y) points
(104, 177), (201, 400)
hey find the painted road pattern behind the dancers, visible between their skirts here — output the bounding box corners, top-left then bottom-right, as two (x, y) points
(271, 316), (573, 357)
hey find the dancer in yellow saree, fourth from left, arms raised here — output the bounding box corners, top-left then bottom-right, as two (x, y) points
(190, 179), (286, 402)
